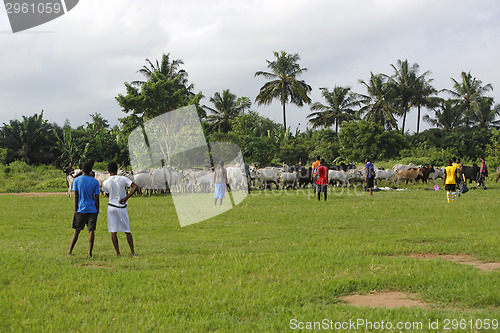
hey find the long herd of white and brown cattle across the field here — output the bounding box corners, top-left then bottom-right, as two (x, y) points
(67, 163), (500, 196)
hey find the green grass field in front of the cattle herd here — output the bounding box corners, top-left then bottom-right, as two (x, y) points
(0, 181), (500, 332)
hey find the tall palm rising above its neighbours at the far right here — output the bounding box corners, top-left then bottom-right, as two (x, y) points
(443, 72), (493, 125)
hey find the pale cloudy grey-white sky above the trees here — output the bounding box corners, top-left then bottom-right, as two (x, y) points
(0, 0), (500, 132)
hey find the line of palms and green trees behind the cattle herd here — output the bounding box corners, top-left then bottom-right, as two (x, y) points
(0, 51), (500, 167)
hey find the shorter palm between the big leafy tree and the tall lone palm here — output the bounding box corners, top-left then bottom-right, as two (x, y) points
(205, 89), (244, 133)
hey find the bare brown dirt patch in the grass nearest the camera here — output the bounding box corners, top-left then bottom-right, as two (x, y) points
(340, 291), (429, 308)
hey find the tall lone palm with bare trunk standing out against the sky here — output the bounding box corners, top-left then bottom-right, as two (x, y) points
(255, 51), (312, 131)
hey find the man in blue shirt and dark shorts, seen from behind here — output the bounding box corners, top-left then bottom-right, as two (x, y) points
(68, 162), (100, 257)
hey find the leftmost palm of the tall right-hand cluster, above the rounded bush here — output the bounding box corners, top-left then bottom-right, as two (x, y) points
(358, 73), (398, 130)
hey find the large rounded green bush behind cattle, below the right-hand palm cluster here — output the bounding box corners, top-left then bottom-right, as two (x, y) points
(339, 120), (408, 162)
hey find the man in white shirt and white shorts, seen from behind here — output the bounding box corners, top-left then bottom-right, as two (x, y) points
(102, 162), (137, 256)
